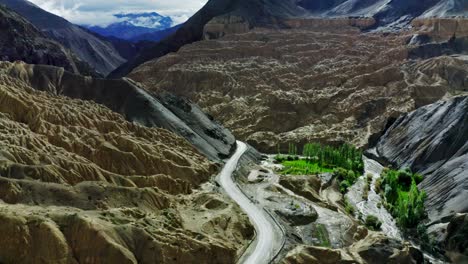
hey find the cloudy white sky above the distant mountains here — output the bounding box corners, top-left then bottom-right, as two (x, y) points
(29, 0), (208, 26)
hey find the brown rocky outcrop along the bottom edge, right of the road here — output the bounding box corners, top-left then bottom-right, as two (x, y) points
(282, 233), (424, 264)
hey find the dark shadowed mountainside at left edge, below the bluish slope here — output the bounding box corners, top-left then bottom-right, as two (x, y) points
(0, 5), (94, 75)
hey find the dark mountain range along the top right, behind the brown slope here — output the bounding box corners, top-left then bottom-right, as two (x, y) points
(110, 0), (468, 77)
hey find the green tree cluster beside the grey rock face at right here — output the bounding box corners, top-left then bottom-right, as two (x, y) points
(376, 169), (427, 228)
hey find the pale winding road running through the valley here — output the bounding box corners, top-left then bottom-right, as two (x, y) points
(219, 141), (283, 264)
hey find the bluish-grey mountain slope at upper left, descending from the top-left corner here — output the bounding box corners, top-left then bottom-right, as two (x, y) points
(0, 0), (126, 75)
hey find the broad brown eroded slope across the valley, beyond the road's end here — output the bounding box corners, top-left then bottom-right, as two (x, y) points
(129, 23), (468, 152)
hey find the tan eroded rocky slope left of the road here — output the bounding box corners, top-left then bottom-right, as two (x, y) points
(0, 62), (252, 263)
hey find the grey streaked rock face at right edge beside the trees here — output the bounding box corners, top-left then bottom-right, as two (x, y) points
(376, 97), (468, 221)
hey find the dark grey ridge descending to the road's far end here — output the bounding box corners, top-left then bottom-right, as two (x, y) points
(4, 63), (235, 160)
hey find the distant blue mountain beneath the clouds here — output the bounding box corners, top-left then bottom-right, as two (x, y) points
(87, 12), (174, 40)
